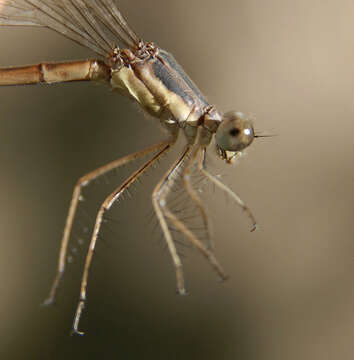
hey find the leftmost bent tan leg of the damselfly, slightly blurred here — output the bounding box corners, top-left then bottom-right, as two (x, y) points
(43, 141), (171, 305)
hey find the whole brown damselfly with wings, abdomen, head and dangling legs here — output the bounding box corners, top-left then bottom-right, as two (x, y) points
(0, 0), (260, 334)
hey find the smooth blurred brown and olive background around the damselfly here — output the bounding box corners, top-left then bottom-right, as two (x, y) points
(0, 0), (354, 360)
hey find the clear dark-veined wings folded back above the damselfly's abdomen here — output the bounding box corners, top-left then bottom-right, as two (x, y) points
(0, 0), (140, 56)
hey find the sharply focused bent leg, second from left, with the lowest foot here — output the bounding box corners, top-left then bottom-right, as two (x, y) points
(72, 140), (174, 335)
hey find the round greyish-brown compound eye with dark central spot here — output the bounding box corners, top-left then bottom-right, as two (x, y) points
(215, 112), (254, 151)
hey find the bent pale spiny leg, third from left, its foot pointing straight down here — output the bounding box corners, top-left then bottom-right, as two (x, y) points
(152, 145), (191, 295)
